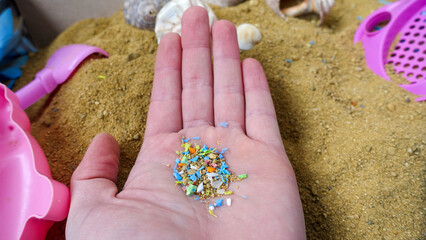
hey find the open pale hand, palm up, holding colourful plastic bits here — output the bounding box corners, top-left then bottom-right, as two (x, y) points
(66, 7), (306, 240)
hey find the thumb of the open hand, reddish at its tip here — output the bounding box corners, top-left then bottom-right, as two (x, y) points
(71, 133), (120, 200)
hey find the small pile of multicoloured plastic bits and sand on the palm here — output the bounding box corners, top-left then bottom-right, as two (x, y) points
(173, 137), (247, 217)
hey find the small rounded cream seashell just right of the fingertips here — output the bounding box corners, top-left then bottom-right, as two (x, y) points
(237, 23), (262, 50)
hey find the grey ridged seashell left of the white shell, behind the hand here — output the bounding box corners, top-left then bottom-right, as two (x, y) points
(123, 0), (169, 30)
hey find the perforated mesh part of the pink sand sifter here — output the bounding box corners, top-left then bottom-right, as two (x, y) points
(388, 5), (426, 82)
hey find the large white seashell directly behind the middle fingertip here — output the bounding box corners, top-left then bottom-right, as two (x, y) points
(155, 0), (217, 43)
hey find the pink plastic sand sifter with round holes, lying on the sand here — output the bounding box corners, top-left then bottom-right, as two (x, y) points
(354, 0), (426, 102)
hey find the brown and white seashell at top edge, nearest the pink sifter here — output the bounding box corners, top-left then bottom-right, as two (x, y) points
(266, 0), (335, 25)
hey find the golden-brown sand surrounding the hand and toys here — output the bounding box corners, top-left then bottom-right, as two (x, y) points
(14, 0), (426, 239)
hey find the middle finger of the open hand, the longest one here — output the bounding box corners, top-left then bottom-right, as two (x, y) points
(182, 7), (213, 128)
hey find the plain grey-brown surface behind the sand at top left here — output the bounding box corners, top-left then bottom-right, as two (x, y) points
(15, 0), (124, 47)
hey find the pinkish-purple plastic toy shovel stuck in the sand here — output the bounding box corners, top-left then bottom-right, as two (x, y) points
(16, 44), (108, 109)
